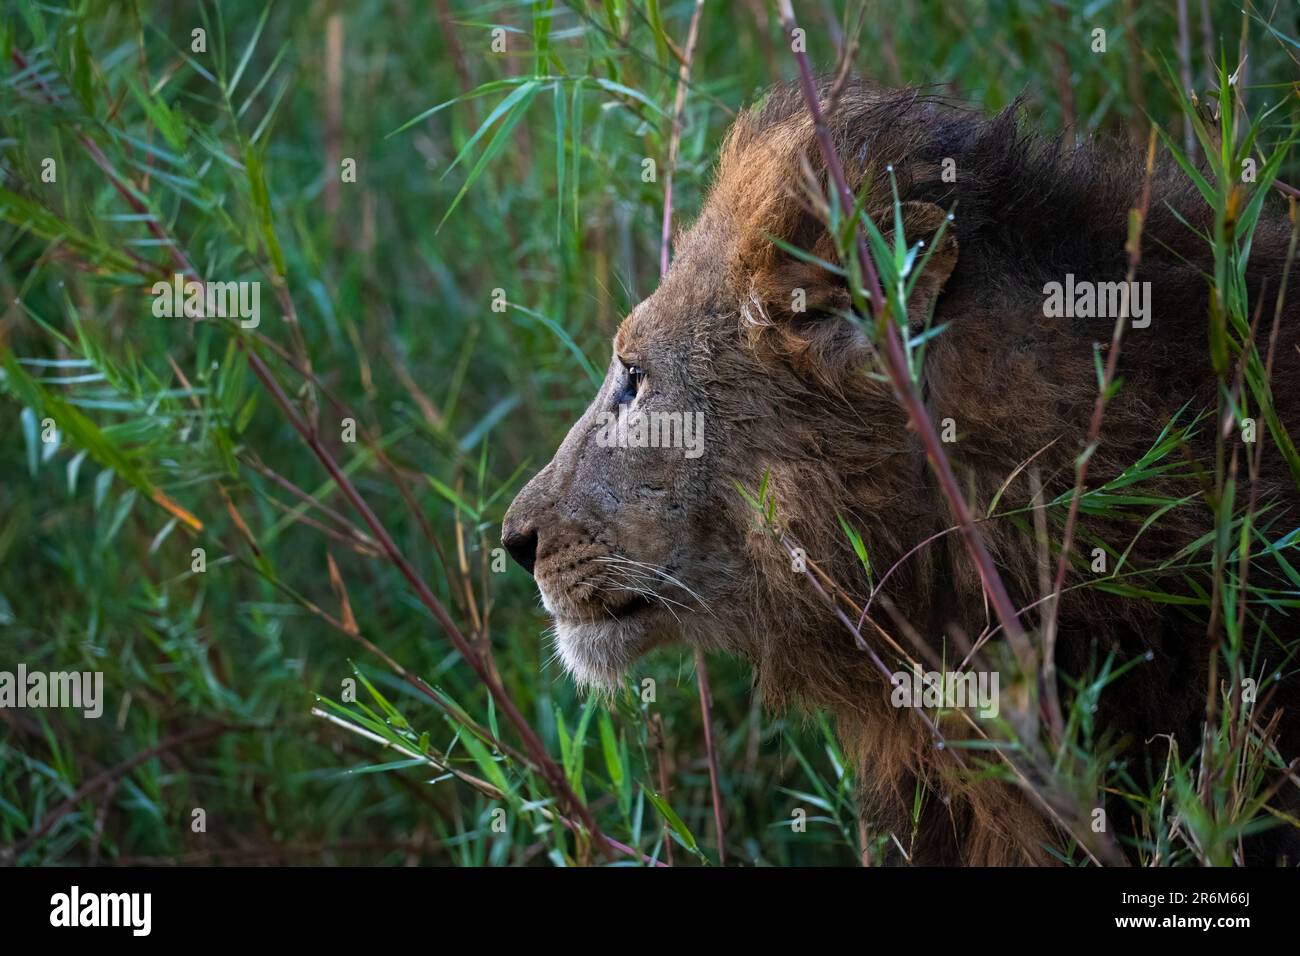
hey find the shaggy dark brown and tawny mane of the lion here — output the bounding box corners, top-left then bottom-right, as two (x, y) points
(670, 85), (1300, 864)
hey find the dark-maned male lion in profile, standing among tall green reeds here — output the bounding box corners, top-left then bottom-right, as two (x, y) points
(502, 81), (1300, 865)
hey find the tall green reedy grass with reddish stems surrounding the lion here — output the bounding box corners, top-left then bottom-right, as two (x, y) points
(0, 0), (1300, 865)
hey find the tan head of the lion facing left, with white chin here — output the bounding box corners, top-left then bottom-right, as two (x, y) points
(502, 83), (957, 688)
